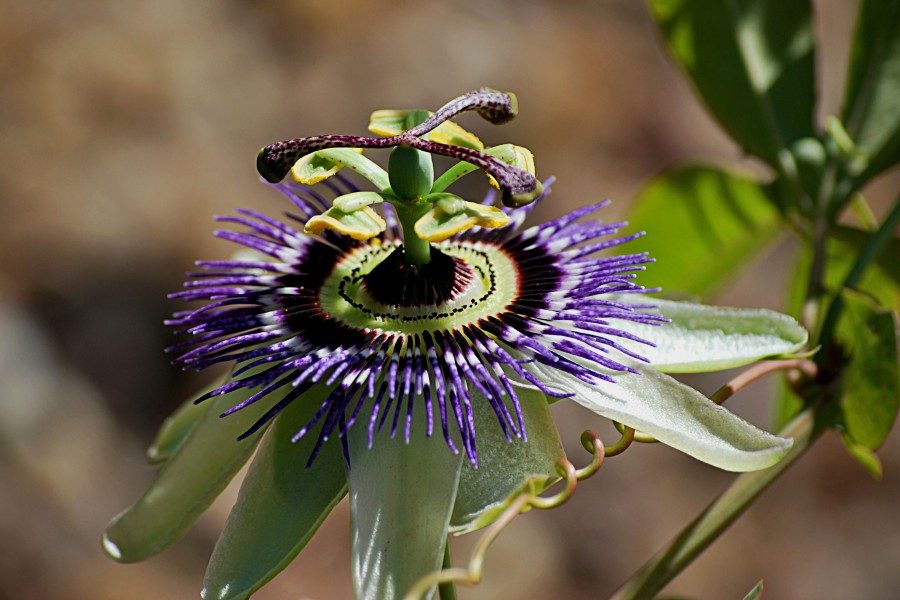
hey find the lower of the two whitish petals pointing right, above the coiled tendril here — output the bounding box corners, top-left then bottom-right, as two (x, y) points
(526, 362), (793, 471)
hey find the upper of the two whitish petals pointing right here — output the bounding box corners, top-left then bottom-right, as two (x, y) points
(615, 294), (807, 373)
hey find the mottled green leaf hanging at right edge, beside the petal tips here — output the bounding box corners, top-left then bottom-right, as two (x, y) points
(836, 290), (900, 450)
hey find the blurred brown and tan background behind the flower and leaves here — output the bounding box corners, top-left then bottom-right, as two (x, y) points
(0, 0), (900, 600)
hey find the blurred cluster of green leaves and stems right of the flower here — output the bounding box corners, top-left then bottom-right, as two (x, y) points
(635, 0), (900, 475)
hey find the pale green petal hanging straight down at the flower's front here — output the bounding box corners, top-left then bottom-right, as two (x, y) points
(347, 408), (464, 600)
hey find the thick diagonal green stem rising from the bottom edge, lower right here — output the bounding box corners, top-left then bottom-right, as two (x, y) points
(611, 409), (824, 600)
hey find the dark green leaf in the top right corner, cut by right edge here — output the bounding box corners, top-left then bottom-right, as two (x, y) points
(842, 0), (900, 181)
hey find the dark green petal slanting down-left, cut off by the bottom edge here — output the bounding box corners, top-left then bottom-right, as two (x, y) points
(200, 387), (347, 600)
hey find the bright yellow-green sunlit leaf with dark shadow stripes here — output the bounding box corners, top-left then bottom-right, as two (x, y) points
(629, 166), (782, 298)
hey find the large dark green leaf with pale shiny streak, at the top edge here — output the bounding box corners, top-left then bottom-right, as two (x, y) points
(650, 0), (816, 171)
